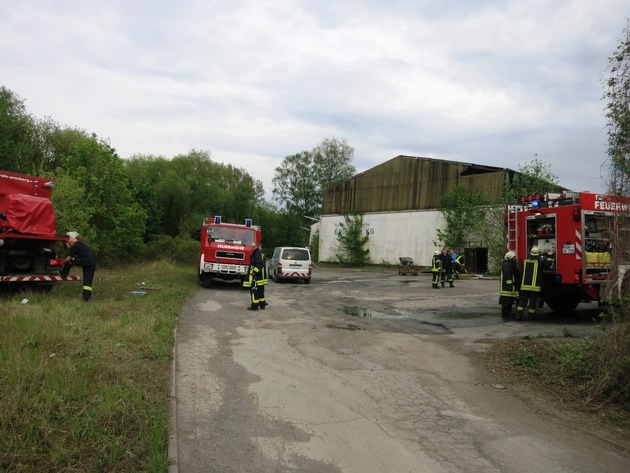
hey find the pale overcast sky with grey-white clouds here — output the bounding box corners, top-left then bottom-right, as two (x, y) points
(0, 0), (630, 197)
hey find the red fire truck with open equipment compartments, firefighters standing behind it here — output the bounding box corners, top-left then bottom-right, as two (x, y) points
(505, 192), (630, 312)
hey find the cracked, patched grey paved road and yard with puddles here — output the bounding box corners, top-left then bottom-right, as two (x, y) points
(169, 268), (630, 473)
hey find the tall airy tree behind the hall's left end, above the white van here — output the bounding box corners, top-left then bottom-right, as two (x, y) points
(272, 138), (356, 219)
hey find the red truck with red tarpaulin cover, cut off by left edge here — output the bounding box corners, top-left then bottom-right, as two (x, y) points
(0, 171), (79, 290)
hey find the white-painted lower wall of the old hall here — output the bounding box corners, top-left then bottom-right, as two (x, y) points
(313, 210), (445, 266)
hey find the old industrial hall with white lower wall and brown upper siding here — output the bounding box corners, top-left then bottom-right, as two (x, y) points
(312, 156), (515, 272)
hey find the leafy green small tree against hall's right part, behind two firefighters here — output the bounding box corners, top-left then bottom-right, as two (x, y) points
(437, 185), (485, 253)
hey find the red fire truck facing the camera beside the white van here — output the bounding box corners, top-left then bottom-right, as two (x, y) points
(198, 216), (261, 287)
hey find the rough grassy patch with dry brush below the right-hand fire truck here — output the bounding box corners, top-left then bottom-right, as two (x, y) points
(487, 305), (630, 429)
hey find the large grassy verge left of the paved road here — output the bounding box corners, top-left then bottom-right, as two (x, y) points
(0, 263), (197, 473)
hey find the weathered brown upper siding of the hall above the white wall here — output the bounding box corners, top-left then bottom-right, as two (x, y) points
(324, 156), (508, 215)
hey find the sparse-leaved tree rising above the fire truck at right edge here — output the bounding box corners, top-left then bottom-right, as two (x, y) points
(604, 20), (630, 195)
